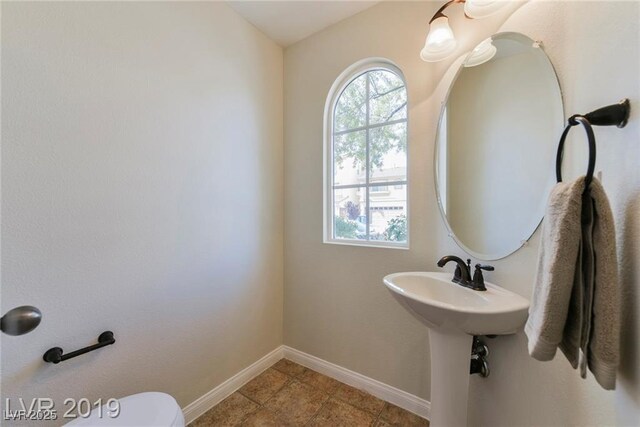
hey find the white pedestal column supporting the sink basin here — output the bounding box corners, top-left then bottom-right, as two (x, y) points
(429, 329), (473, 427)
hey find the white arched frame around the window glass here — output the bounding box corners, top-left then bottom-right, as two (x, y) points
(322, 58), (411, 250)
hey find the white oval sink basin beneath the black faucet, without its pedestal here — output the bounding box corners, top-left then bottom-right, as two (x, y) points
(383, 272), (529, 335)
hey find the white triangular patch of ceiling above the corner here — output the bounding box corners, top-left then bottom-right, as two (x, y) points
(227, 0), (379, 47)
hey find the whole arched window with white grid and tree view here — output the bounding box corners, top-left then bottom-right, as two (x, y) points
(324, 60), (409, 248)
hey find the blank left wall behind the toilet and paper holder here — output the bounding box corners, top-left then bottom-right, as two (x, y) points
(1, 2), (283, 425)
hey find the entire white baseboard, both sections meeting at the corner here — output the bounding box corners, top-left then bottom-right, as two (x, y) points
(182, 345), (431, 424)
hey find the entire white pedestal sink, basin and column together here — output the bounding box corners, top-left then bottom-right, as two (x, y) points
(383, 272), (529, 427)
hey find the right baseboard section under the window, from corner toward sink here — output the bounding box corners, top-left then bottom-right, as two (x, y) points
(283, 346), (431, 419)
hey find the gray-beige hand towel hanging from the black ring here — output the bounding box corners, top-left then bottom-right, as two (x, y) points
(525, 177), (620, 390)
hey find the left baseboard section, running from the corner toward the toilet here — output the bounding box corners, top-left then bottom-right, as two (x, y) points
(182, 346), (284, 425)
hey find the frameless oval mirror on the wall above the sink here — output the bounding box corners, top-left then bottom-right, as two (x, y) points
(434, 33), (564, 260)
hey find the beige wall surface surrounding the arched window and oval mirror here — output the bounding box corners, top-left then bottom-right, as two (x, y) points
(284, 1), (640, 426)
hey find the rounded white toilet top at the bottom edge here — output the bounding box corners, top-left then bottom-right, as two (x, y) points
(65, 391), (184, 427)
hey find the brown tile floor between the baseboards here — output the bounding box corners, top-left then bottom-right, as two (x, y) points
(189, 359), (429, 427)
